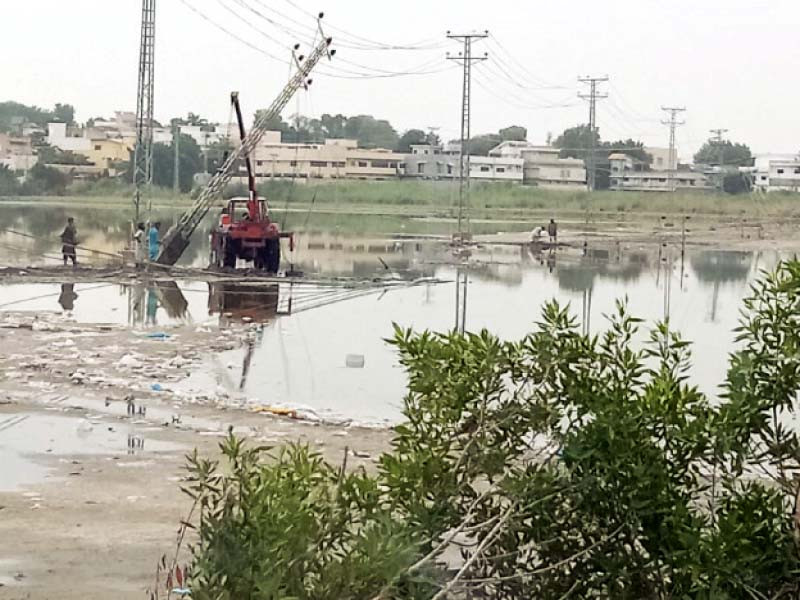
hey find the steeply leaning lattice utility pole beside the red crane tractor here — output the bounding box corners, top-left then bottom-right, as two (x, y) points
(156, 35), (334, 265)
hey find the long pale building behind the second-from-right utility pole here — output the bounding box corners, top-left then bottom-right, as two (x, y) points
(608, 152), (713, 192)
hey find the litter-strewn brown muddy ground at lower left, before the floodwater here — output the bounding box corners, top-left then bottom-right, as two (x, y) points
(0, 313), (389, 600)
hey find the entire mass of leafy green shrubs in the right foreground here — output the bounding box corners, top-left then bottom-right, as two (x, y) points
(177, 262), (800, 600)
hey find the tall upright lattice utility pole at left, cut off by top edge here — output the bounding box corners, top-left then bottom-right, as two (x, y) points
(133, 0), (156, 223)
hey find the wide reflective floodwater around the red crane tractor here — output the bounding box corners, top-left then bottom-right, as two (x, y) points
(0, 204), (780, 423)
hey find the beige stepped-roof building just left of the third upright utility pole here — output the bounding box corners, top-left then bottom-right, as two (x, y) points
(489, 141), (586, 189)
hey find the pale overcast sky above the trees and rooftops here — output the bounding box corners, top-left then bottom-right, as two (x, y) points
(0, 0), (800, 157)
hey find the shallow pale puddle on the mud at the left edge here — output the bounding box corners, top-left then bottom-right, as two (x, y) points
(0, 413), (183, 492)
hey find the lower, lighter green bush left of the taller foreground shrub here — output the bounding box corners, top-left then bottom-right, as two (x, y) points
(185, 436), (435, 600)
